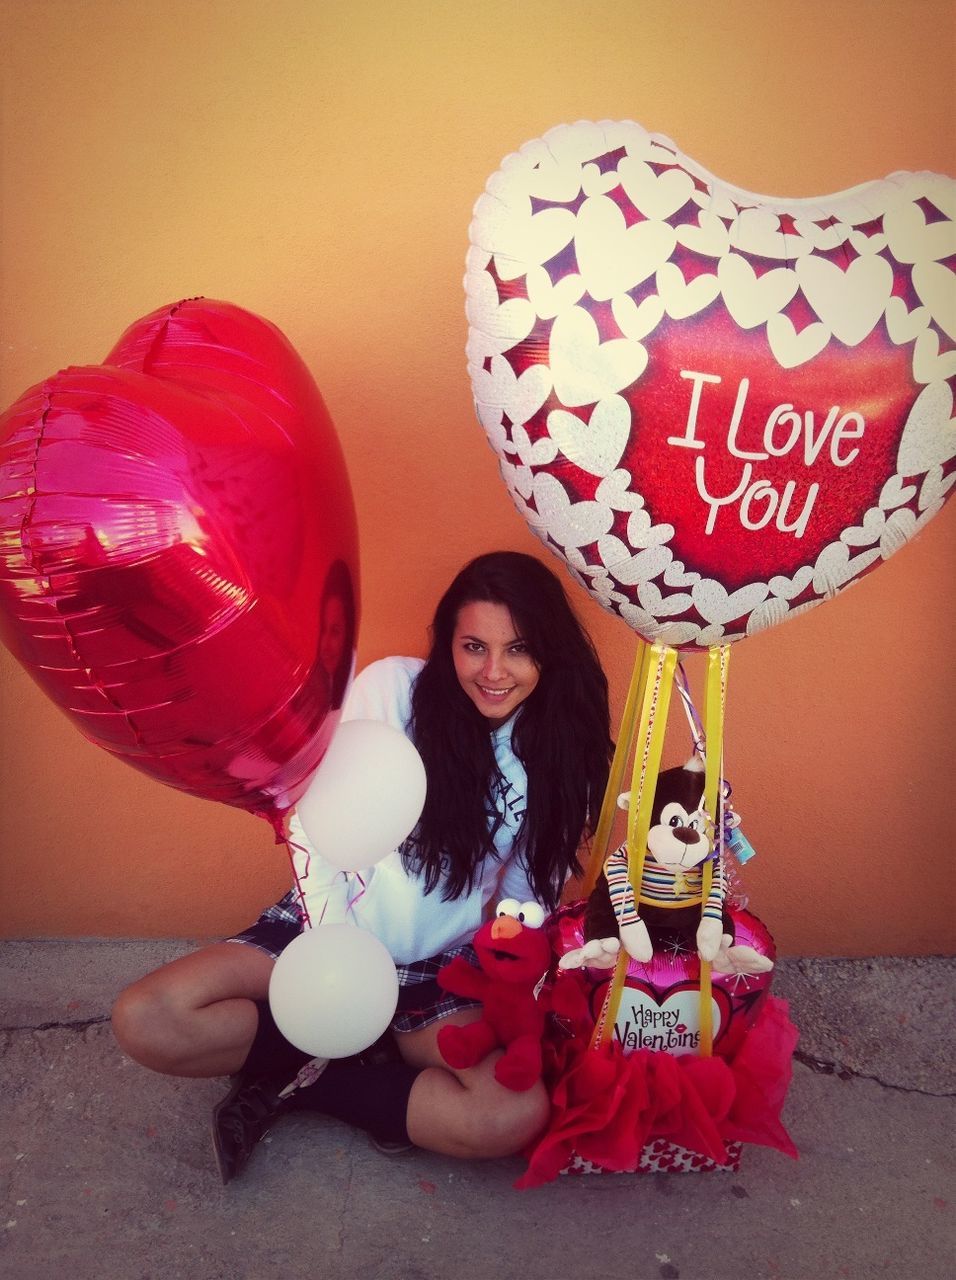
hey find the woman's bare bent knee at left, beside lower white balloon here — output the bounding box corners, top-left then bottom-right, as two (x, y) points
(113, 942), (275, 1076)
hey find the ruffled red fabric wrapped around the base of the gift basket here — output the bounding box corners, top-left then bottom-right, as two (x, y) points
(514, 982), (797, 1188)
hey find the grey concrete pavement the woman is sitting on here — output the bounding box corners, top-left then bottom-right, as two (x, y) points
(0, 941), (956, 1280)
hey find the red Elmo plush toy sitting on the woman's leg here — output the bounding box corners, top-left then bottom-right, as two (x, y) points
(438, 899), (552, 1092)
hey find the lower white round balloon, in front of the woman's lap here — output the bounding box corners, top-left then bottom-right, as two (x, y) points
(269, 924), (398, 1057)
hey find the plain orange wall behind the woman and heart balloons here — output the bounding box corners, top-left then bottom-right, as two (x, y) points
(0, 0), (956, 955)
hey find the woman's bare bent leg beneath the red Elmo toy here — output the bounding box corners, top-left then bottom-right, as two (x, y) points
(395, 1009), (550, 1160)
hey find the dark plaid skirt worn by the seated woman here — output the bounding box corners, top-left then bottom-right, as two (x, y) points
(227, 891), (477, 1032)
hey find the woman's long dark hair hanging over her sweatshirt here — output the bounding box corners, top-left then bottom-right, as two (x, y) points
(403, 552), (613, 909)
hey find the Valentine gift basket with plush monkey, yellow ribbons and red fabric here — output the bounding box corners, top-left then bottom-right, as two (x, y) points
(517, 645), (797, 1188)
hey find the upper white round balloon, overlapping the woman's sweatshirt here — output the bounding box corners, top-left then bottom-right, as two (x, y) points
(296, 719), (425, 872)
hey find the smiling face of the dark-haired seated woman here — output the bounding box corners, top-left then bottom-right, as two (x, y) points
(452, 600), (540, 728)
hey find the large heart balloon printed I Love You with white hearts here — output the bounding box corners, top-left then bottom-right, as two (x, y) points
(465, 122), (956, 649)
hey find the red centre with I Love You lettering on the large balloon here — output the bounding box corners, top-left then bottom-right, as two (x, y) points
(614, 308), (914, 590)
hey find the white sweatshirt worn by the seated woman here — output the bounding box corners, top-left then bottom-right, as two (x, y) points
(289, 658), (534, 964)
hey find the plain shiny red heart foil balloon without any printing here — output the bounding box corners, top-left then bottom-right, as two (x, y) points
(0, 300), (358, 824)
